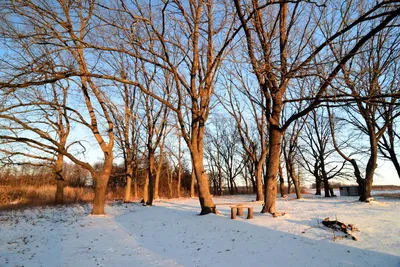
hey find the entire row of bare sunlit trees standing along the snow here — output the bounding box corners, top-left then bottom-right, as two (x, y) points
(0, 0), (400, 217)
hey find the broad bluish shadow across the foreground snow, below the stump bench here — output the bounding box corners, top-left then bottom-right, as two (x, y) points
(115, 202), (400, 267)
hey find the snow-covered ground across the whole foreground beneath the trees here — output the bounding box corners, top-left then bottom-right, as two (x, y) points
(0, 196), (400, 267)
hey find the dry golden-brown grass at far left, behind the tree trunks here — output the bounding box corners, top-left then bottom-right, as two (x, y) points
(0, 185), (94, 209)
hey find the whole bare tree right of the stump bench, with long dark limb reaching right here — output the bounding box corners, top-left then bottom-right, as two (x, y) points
(235, 0), (400, 213)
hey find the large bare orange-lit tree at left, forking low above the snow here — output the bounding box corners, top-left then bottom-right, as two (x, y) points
(0, 1), (114, 214)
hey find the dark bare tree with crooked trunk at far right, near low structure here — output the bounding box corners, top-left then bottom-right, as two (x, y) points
(332, 25), (400, 201)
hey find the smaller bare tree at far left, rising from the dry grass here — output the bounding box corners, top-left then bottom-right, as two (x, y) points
(0, 78), (71, 204)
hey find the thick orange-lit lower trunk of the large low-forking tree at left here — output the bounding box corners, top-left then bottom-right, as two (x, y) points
(92, 155), (113, 215)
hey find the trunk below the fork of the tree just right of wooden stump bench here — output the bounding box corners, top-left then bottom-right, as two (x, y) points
(261, 126), (282, 214)
